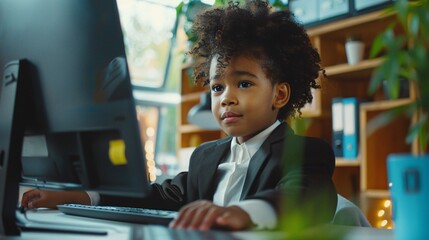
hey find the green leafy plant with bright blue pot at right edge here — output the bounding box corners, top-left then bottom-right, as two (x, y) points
(369, 0), (429, 239)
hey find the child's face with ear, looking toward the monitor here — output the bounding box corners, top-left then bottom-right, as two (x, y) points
(210, 55), (290, 143)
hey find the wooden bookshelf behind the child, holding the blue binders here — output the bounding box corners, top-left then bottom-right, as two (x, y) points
(306, 11), (415, 227)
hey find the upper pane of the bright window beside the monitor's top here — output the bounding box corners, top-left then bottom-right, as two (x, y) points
(117, 0), (181, 90)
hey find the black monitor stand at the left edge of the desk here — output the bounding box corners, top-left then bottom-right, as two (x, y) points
(0, 60), (107, 238)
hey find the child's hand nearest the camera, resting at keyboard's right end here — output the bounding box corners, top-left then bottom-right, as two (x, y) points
(170, 200), (253, 230)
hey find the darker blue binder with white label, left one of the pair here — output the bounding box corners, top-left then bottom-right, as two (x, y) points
(331, 98), (344, 157)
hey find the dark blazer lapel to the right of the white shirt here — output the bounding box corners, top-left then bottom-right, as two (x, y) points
(240, 123), (289, 199)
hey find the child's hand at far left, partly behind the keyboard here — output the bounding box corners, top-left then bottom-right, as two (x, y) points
(21, 189), (91, 208)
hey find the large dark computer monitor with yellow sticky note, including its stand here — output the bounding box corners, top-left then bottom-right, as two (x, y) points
(0, 0), (150, 235)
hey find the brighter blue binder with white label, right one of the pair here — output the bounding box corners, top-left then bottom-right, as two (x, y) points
(343, 98), (359, 159)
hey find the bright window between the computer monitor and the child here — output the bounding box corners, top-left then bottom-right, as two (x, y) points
(117, 0), (183, 181)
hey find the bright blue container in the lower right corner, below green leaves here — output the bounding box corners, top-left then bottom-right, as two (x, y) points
(387, 154), (429, 240)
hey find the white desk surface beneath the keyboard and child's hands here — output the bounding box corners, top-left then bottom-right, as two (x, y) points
(0, 210), (393, 240)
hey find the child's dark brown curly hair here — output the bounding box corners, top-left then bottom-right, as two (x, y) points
(189, 0), (324, 119)
